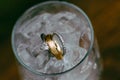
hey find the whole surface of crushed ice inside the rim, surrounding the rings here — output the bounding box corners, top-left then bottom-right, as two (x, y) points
(16, 12), (88, 73)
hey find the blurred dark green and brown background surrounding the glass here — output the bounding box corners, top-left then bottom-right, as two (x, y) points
(0, 0), (120, 80)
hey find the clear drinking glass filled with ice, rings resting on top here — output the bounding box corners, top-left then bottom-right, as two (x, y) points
(12, 1), (102, 80)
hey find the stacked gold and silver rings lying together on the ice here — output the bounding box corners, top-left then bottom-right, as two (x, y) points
(45, 33), (65, 60)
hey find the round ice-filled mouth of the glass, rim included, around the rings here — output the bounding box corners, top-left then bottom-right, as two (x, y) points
(12, 1), (94, 75)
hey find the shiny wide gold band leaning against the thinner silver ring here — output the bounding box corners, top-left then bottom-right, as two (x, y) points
(45, 34), (63, 60)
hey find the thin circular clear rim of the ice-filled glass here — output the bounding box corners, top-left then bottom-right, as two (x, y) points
(11, 1), (94, 76)
